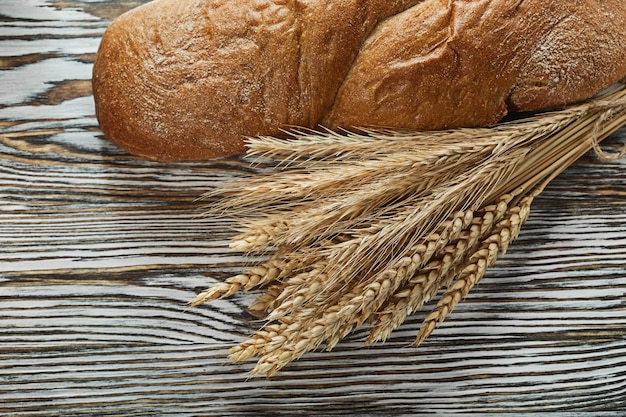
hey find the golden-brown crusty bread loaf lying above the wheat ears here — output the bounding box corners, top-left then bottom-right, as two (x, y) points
(93, 0), (626, 161)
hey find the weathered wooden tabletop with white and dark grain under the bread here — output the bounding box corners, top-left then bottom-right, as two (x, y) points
(0, 0), (626, 416)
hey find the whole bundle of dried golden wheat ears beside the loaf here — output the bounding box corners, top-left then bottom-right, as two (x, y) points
(192, 84), (626, 376)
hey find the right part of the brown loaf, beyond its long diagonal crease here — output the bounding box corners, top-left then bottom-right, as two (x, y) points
(325, 0), (626, 129)
